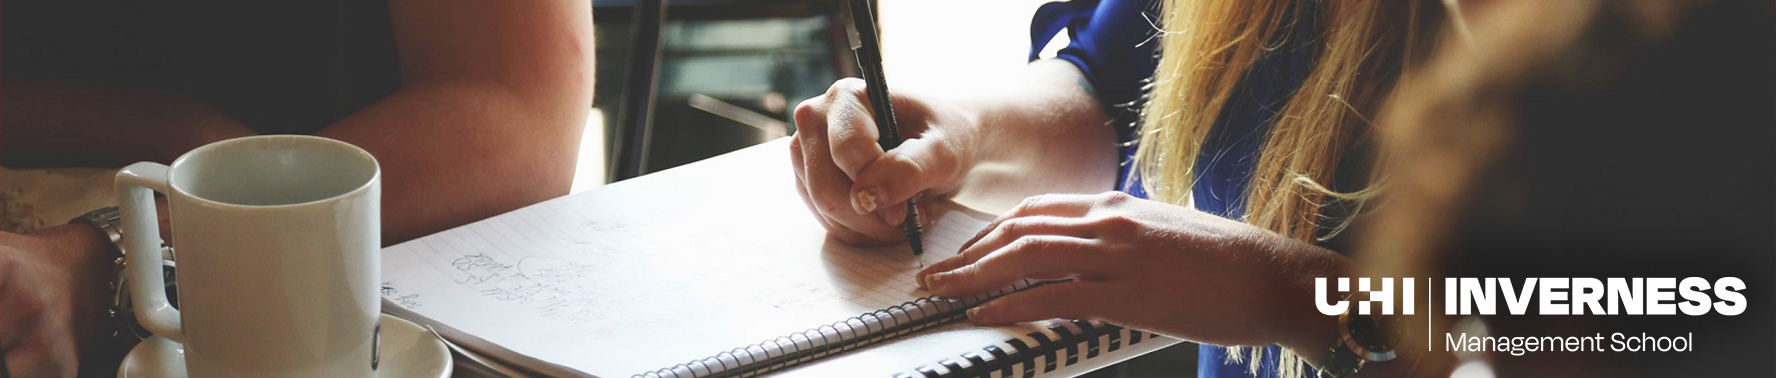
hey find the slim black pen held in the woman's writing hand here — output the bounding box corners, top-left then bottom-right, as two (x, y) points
(849, 0), (925, 256)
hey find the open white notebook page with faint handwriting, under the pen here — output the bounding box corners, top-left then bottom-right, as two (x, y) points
(382, 140), (986, 376)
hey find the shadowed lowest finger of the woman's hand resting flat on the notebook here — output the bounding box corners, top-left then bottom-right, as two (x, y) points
(968, 280), (1114, 325)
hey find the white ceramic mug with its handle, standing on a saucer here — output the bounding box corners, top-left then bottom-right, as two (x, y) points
(117, 135), (382, 378)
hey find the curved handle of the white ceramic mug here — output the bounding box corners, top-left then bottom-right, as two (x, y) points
(117, 161), (185, 343)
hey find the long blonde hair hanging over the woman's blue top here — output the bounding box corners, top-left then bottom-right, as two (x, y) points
(1126, 0), (1444, 376)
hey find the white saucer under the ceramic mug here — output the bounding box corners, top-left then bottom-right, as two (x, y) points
(117, 314), (451, 378)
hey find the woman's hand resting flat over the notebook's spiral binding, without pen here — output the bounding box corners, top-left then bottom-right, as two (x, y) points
(918, 192), (1348, 350)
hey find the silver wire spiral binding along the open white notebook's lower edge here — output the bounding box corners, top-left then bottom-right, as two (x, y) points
(632, 280), (1044, 378)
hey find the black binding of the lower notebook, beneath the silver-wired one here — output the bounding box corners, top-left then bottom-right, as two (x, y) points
(895, 319), (1160, 378)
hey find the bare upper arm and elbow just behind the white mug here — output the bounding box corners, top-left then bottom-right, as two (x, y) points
(318, 0), (593, 243)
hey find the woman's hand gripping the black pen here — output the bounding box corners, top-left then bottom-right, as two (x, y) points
(790, 78), (979, 245)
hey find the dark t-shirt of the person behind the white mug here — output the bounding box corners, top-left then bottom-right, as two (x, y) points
(0, 0), (400, 133)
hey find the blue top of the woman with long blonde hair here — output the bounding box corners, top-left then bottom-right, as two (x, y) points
(1030, 0), (1316, 376)
